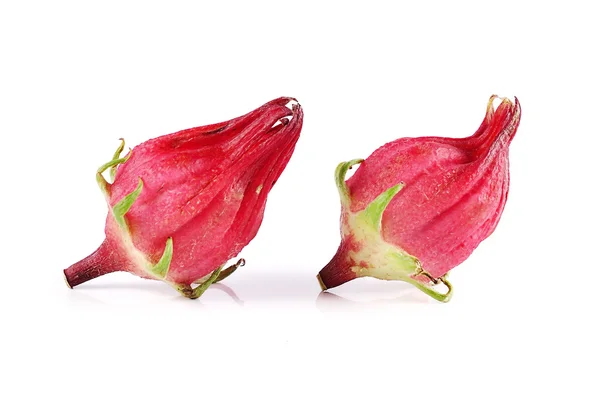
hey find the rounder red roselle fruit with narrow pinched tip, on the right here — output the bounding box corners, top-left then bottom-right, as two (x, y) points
(317, 96), (521, 302)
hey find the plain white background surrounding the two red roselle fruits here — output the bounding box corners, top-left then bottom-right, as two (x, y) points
(0, 0), (600, 405)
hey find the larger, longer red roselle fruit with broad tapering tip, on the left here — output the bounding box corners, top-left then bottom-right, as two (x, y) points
(64, 97), (303, 298)
